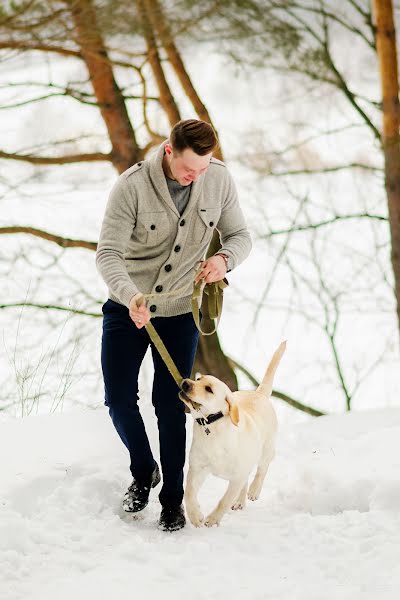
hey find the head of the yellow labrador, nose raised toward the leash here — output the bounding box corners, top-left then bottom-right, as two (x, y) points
(179, 375), (239, 426)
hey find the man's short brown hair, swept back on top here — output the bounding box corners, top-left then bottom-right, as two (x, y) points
(169, 119), (219, 156)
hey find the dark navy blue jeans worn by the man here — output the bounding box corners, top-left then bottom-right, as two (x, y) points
(101, 300), (198, 506)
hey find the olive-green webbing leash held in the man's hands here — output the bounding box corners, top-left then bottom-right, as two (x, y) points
(136, 279), (229, 387)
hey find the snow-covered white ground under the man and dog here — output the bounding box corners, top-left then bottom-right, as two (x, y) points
(0, 404), (400, 600)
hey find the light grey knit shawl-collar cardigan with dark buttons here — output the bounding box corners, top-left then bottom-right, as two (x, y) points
(96, 142), (251, 317)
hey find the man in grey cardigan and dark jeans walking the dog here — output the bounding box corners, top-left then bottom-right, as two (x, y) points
(96, 119), (251, 531)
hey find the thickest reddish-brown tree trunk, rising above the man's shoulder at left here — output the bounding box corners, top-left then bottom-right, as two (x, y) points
(69, 0), (142, 173)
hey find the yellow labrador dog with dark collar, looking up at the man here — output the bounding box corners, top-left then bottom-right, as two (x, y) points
(179, 342), (286, 527)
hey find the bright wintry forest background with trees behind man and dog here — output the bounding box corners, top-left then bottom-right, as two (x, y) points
(0, 0), (400, 421)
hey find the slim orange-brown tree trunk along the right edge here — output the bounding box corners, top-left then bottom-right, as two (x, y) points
(374, 0), (400, 342)
